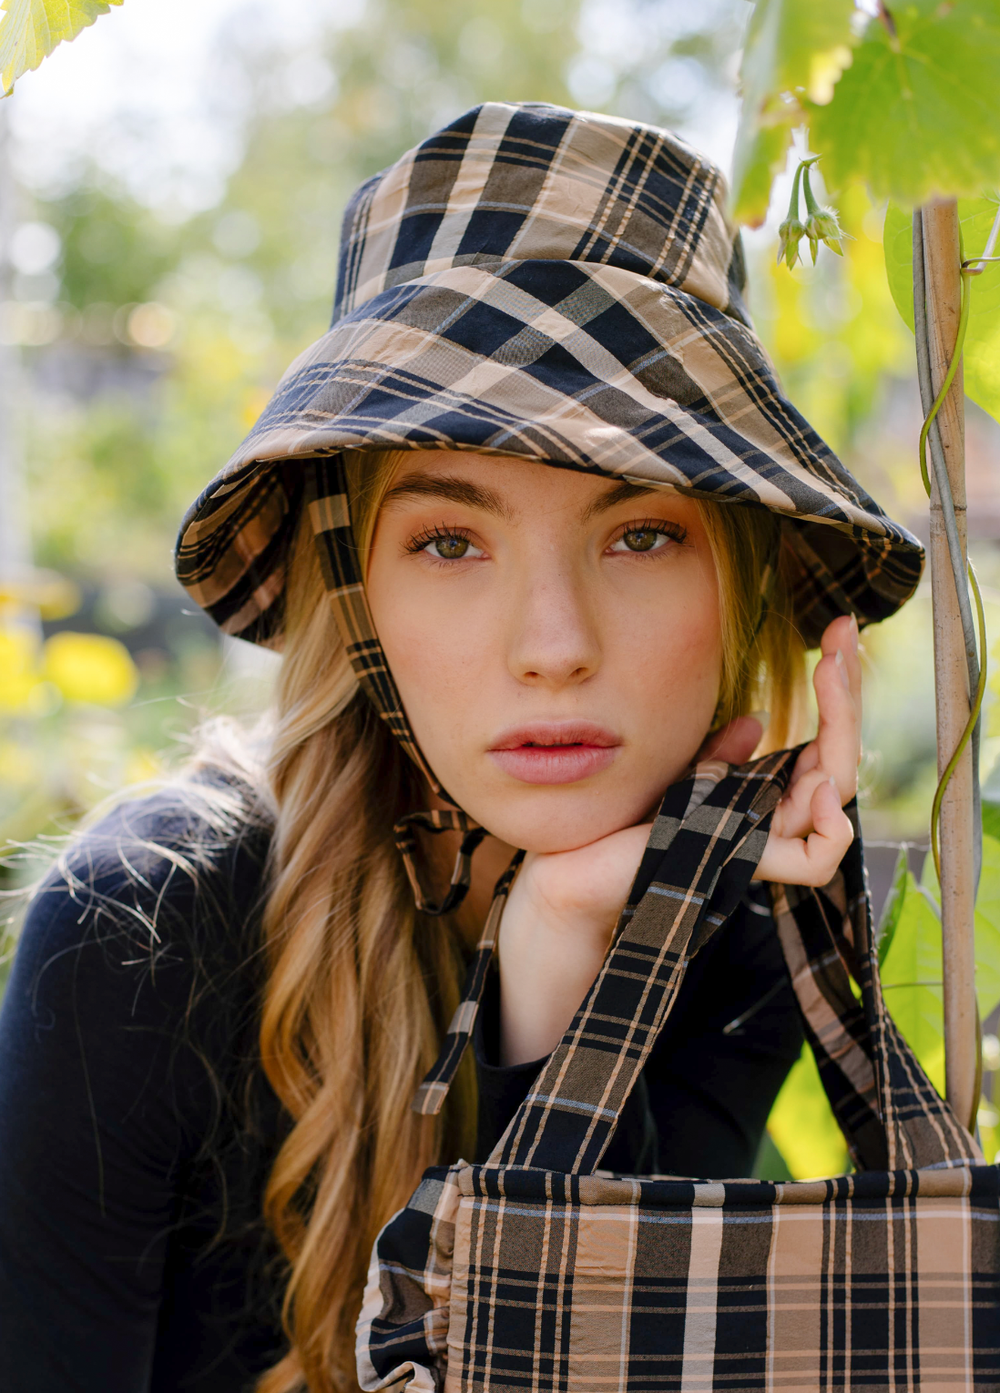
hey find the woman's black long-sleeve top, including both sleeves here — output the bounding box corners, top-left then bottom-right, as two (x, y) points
(0, 790), (802, 1393)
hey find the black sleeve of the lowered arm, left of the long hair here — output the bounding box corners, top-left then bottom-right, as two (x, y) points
(0, 791), (271, 1393)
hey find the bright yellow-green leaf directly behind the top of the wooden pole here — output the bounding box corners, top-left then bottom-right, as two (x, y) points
(882, 198), (1000, 421)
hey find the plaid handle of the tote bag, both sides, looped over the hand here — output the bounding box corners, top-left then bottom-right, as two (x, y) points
(489, 749), (983, 1173)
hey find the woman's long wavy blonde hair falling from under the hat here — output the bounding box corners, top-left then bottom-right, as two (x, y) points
(258, 451), (804, 1393)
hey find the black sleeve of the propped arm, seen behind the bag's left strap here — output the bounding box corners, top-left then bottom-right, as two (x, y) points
(474, 886), (804, 1178)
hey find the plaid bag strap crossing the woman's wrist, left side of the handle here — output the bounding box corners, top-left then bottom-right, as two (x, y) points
(487, 749), (797, 1173)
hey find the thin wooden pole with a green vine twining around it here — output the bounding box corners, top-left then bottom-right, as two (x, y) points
(922, 199), (979, 1123)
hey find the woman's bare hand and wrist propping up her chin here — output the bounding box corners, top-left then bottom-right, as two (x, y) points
(497, 617), (861, 1064)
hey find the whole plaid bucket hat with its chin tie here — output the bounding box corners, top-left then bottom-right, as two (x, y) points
(175, 102), (923, 846)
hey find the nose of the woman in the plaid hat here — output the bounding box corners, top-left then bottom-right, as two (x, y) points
(507, 553), (600, 690)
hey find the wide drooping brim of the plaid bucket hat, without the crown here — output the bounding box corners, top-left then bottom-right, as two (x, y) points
(177, 256), (923, 646)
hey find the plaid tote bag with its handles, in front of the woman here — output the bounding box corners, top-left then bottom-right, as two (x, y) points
(358, 751), (1000, 1393)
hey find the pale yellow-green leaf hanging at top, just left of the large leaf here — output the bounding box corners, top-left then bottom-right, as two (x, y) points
(733, 0), (855, 223)
